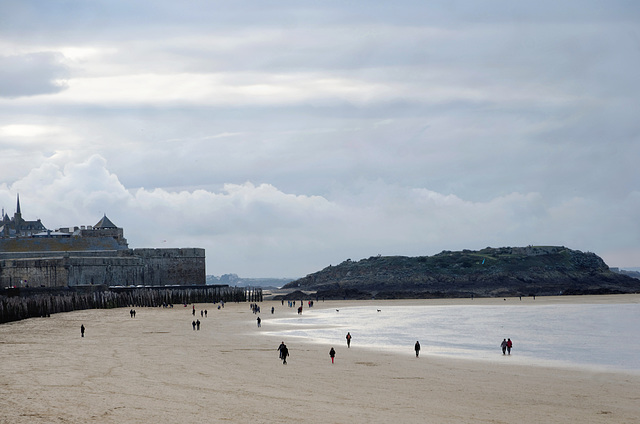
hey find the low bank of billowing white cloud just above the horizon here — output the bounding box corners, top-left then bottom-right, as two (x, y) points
(0, 156), (640, 276)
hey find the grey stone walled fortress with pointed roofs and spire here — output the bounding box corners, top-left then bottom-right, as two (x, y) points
(0, 198), (206, 287)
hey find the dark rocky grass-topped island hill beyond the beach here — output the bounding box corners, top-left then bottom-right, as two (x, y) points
(283, 246), (640, 299)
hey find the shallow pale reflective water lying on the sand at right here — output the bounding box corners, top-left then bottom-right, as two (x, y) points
(262, 304), (640, 373)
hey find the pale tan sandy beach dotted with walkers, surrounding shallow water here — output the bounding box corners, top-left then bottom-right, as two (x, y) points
(0, 295), (640, 424)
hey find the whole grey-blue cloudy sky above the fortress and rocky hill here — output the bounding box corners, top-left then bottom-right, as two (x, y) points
(0, 0), (640, 277)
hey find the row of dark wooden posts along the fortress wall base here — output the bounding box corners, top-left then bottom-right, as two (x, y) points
(0, 287), (263, 323)
